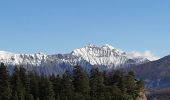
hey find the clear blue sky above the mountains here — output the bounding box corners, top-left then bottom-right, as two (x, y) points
(0, 0), (170, 56)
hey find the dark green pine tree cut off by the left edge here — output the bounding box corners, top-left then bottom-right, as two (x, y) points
(0, 63), (11, 100)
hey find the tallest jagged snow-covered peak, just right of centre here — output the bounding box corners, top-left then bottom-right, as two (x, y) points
(71, 44), (145, 67)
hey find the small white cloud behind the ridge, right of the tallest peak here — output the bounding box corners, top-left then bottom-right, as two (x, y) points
(131, 50), (159, 61)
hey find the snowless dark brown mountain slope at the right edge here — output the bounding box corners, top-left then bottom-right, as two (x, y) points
(131, 56), (170, 88)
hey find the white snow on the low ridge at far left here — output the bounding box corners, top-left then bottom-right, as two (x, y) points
(0, 51), (47, 66)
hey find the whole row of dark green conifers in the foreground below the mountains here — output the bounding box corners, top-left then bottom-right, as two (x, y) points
(0, 63), (144, 100)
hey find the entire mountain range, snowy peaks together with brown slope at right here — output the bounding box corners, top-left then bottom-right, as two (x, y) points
(0, 44), (170, 88)
